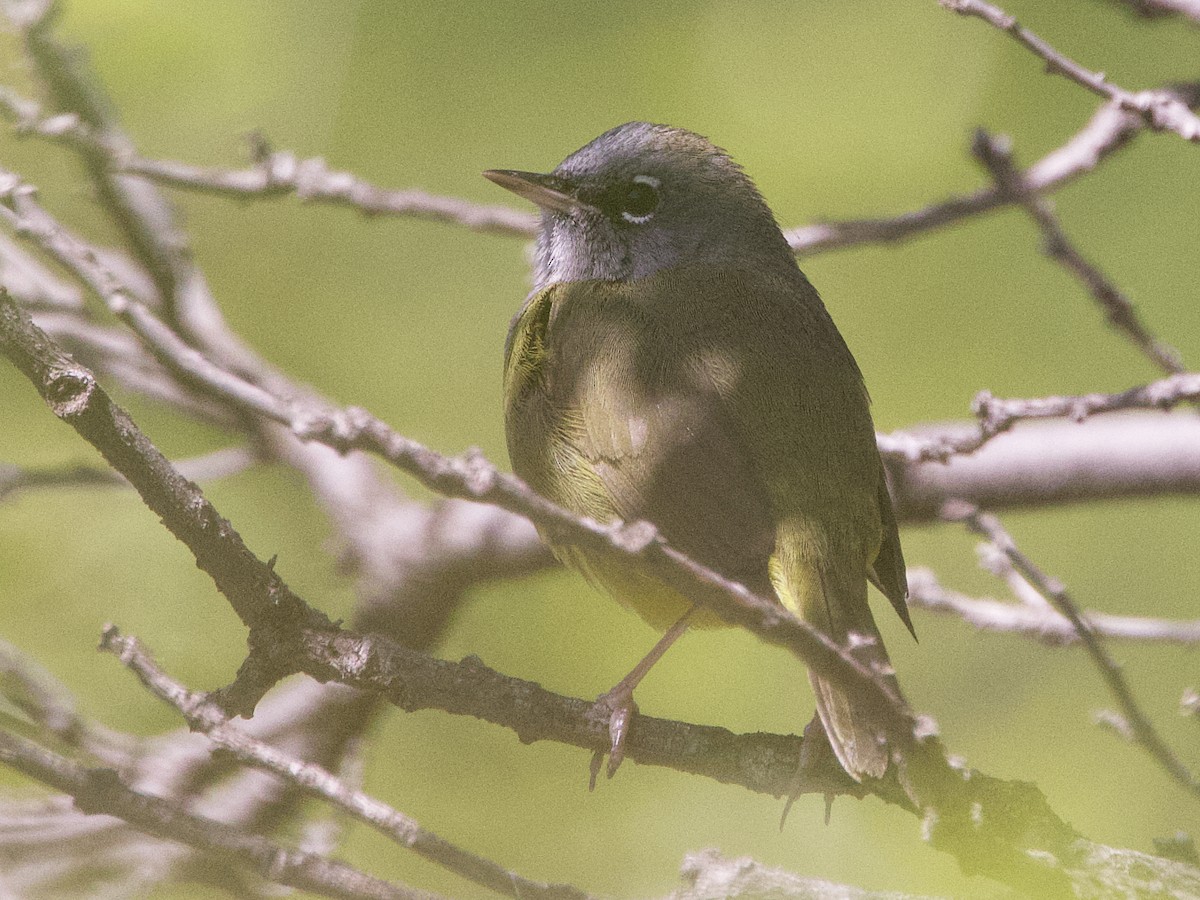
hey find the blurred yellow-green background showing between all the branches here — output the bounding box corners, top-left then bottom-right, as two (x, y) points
(0, 0), (1200, 896)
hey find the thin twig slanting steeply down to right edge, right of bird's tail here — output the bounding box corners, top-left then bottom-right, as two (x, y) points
(943, 503), (1200, 796)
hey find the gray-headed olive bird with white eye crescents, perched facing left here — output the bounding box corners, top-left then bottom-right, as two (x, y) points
(484, 121), (916, 786)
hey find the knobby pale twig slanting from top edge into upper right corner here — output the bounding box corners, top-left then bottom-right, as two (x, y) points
(938, 0), (1200, 142)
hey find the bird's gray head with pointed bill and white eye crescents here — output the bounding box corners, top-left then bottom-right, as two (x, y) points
(484, 122), (796, 288)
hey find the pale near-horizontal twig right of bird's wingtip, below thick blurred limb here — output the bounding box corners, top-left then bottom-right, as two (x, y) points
(908, 568), (1200, 647)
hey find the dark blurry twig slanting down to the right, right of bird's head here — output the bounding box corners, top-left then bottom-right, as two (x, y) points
(971, 128), (1184, 374)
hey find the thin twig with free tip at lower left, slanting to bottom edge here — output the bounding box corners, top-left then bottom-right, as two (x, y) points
(100, 625), (589, 900)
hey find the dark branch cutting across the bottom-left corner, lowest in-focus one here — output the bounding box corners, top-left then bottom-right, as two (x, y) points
(0, 728), (434, 900)
